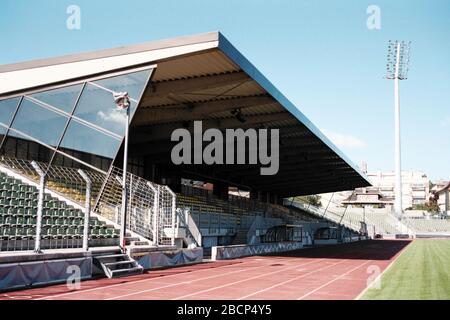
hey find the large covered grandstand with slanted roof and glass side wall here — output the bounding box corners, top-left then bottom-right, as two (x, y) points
(0, 32), (376, 288)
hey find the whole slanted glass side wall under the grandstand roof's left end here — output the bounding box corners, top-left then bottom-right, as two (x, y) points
(0, 69), (153, 171)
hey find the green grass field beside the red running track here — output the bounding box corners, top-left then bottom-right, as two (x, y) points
(361, 240), (450, 300)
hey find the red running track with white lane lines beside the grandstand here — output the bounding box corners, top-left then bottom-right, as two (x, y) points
(0, 240), (409, 300)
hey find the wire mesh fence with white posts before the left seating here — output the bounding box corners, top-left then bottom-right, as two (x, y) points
(0, 157), (176, 250)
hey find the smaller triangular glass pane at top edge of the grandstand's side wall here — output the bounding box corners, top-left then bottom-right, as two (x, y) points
(31, 84), (83, 113)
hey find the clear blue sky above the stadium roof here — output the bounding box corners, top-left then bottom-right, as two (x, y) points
(0, 0), (450, 179)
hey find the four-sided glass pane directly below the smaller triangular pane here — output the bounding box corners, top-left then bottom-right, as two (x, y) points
(10, 98), (68, 146)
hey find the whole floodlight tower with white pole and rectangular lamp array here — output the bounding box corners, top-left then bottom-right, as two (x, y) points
(387, 40), (411, 218)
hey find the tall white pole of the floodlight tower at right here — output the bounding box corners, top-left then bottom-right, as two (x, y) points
(394, 43), (403, 218)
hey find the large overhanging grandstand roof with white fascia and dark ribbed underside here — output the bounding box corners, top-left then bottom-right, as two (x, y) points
(0, 32), (370, 197)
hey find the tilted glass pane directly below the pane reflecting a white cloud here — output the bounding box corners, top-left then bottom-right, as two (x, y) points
(61, 119), (121, 160)
